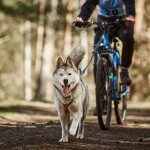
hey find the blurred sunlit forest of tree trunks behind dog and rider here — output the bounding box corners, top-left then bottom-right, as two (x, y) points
(0, 0), (150, 101)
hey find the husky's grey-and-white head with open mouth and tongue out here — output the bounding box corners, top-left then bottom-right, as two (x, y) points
(53, 57), (80, 97)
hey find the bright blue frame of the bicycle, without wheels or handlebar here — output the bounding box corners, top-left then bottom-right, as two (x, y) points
(95, 33), (129, 101)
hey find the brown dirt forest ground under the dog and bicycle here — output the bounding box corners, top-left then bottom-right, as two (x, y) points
(0, 100), (150, 150)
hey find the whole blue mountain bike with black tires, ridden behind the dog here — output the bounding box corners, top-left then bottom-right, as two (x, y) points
(74, 19), (129, 130)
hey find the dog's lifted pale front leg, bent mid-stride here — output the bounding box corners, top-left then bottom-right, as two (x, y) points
(69, 111), (82, 136)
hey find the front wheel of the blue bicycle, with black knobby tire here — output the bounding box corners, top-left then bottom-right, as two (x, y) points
(96, 58), (112, 130)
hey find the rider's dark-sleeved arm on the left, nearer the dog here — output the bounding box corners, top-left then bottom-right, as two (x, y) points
(78, 0), (98, 20)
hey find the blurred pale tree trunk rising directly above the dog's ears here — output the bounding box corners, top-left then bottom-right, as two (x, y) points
(64, 0), (73, 56)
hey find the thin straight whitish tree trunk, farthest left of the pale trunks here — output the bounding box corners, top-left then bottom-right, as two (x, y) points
(24, 21), (32, 101)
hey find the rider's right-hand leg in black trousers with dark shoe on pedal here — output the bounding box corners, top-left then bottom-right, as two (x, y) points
(118, 25), (134, 84)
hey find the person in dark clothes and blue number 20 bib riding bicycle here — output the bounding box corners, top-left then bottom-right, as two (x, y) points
(74, 0), (135, 84)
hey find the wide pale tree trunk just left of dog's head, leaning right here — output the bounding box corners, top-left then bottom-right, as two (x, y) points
(39, 1), (58, 100)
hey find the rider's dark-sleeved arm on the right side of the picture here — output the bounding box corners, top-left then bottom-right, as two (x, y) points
(123, 0), (135, 17)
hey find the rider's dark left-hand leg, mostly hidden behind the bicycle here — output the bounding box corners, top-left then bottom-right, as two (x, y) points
(93, 29), (102, 83)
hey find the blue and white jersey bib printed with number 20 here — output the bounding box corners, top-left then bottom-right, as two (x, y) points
(97, 0), (126, 17)
